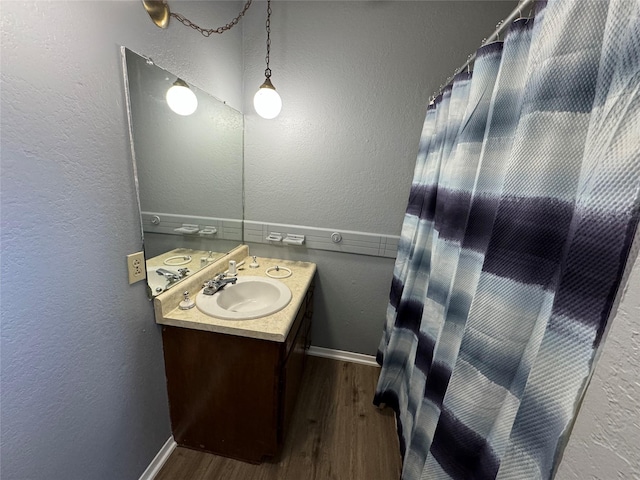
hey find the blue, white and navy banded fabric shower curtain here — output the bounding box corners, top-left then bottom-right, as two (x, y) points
(374, 0), (640, 480)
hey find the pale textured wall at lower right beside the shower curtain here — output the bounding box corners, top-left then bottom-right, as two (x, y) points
(556, 248), (640, 480)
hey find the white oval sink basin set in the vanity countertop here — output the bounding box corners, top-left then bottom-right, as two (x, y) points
(196, 276), (291, 320)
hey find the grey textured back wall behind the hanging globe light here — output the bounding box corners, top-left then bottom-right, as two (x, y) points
(244, 1), (515, 355)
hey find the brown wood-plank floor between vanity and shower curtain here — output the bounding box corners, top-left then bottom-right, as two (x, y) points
(156, 357), (401, 480)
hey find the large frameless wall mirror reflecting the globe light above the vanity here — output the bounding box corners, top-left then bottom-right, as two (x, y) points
(122, 47), (244, 295)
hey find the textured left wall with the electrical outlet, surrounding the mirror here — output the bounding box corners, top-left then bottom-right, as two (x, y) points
(0, 0), (242, 480)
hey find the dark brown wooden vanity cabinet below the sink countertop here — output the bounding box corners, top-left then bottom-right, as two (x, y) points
(162, 284), (313, 463)
